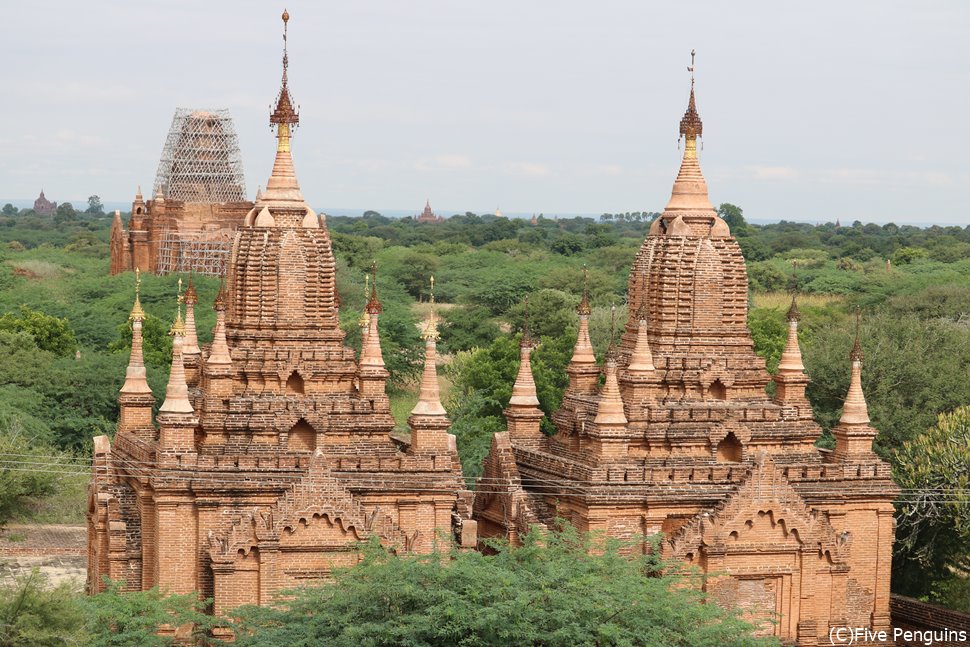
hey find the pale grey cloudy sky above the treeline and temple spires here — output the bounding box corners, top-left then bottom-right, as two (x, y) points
(0, 0), (970, 224)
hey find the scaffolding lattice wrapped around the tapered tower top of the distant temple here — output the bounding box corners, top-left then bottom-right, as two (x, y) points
(155, 108), (246, 204)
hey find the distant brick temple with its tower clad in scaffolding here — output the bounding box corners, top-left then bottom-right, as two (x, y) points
(110, 108), (253, 276)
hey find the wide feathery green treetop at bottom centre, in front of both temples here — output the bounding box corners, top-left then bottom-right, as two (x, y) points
(234, 525), (778, 647)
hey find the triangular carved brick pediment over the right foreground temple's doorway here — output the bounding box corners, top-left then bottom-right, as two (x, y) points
(667, 453), (842, 563)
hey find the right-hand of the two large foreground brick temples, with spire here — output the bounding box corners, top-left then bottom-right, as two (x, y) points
(474, 58), (898, 645)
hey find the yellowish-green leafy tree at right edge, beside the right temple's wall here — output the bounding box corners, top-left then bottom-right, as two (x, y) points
(893, 406), (970, 612)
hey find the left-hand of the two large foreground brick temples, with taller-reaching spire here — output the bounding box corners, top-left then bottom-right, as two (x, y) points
(88, 12), (477, 628)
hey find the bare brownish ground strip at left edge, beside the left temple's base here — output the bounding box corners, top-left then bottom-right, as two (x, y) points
(0, 525), (87, 590)
